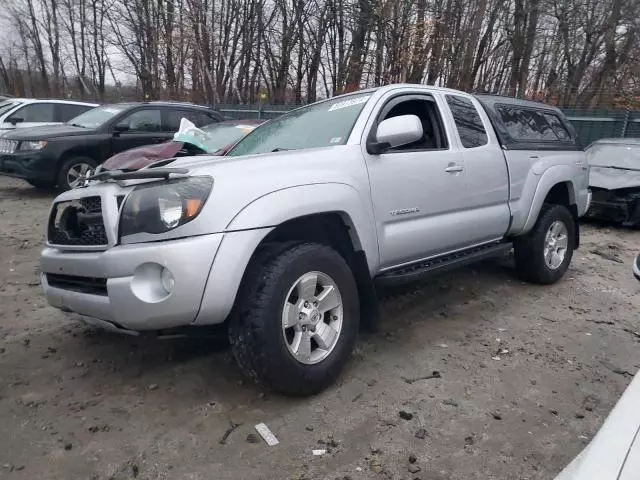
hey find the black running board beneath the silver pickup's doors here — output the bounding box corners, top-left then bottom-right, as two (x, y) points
(375, 242), (513, 287)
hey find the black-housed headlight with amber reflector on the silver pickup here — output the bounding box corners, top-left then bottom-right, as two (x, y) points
(120, 177), (213, 237)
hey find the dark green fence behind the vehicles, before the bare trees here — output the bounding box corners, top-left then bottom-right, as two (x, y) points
(216, 104), (640, 146)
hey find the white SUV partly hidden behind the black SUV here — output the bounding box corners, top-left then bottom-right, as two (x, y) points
(0, 98), (98, 136)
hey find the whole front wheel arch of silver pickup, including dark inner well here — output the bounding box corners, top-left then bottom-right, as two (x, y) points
(195, 184), (378, 330)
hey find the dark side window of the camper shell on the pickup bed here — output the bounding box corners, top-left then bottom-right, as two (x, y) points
(497, 106), (558, 142)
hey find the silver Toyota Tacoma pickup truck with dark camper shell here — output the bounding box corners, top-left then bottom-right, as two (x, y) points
(41, 85), (590, 395)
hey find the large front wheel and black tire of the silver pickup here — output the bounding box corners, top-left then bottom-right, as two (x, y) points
(229, 243), (360, 396)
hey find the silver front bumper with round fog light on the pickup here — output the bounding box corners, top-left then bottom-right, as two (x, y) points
(41, 233), (224, 332)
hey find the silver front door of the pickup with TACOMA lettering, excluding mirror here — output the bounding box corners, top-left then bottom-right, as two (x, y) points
(363, 94), (471, 269)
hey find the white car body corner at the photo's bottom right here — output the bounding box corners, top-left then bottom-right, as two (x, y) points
(555, 373), (640, 480)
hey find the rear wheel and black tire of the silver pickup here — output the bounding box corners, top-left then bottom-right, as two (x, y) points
(514, 204), (575, 285)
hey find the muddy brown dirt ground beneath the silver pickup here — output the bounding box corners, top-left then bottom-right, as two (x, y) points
(0, 177), (640, 480)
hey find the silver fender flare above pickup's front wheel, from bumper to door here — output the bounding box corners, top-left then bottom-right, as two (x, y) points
(225, 183), (379, 275)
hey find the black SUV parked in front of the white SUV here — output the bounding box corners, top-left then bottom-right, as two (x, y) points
(0, 102), (222, 190)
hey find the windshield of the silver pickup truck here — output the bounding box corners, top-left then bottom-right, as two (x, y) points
(227, 93), (371, 156)
